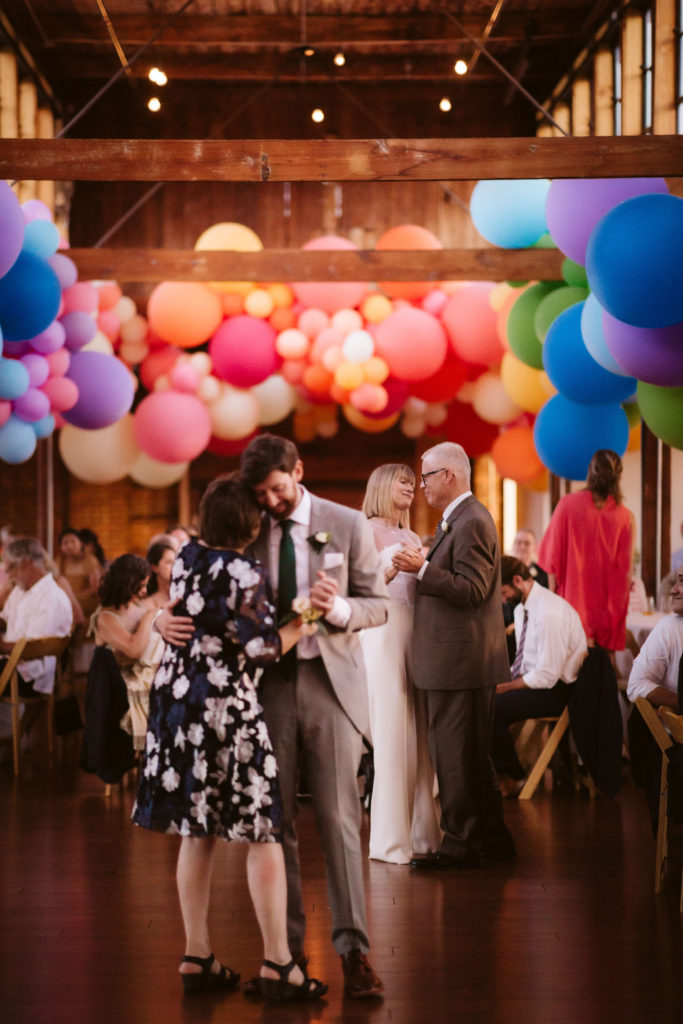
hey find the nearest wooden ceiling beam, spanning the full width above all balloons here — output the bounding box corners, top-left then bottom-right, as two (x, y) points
(0, 135), (683, 181)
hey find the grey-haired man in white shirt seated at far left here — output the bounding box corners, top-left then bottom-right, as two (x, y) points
(0, 537), (73, 697)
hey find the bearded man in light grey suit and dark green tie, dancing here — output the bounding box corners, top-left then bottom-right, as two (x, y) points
(240, 434), (388, 998)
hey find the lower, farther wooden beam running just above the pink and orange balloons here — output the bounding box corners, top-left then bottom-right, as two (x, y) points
(69, 249), (563, 282)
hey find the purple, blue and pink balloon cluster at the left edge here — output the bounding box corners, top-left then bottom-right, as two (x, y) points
(0, 181), (134, 464)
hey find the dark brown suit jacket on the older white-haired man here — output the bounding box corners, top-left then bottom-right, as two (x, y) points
(412, 495), (509, 690)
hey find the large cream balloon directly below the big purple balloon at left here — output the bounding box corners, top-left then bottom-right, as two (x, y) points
(59, 413), (140, 483)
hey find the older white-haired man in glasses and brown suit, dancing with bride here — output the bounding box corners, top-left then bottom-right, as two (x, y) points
(394, 442), (515, 870)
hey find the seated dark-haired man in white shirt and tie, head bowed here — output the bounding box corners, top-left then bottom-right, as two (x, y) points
(492, 555), (588, 797)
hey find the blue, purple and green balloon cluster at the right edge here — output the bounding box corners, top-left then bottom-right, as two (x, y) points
(471, 178), (683, 480)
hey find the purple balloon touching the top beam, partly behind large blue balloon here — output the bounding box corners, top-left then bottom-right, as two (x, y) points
(546, 178), (669, 266)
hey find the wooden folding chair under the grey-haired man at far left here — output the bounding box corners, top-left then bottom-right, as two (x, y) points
(0, 634), (71, 775)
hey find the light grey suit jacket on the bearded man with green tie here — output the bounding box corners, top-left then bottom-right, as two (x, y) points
(250, 495), (389, 735)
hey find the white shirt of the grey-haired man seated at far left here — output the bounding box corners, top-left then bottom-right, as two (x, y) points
(2, 572), (74, 693)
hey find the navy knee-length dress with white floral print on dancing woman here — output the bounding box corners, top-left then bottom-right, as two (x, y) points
(133, 541), (282, 842)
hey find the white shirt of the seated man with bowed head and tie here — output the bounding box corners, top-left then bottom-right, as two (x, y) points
(514, 583), (588, 689)
